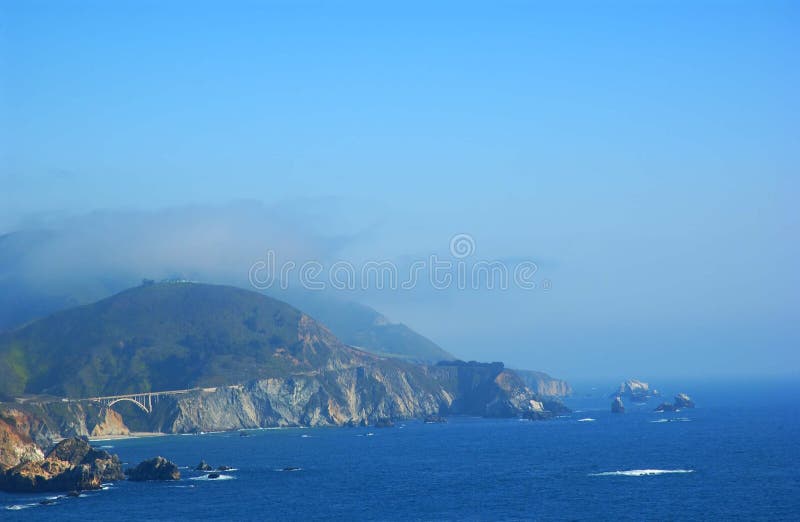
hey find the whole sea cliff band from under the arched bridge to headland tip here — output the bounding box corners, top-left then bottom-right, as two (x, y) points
(4, 360), (568, 436)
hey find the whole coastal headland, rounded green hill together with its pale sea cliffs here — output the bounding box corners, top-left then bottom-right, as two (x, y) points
(0, 283), (563, 435)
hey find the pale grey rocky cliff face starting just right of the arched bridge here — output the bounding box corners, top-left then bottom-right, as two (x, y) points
(145, 361), (564, 433)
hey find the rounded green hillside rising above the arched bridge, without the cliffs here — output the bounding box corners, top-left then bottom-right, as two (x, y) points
(0, 283), (355, 397)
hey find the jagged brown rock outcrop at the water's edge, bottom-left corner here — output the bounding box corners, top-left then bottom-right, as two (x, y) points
(0, 438), (124, 492)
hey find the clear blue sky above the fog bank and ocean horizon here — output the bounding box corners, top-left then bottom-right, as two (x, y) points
(0, 1), (800, 375)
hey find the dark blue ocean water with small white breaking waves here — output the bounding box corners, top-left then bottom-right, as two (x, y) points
(0, 376), (800, 521)
